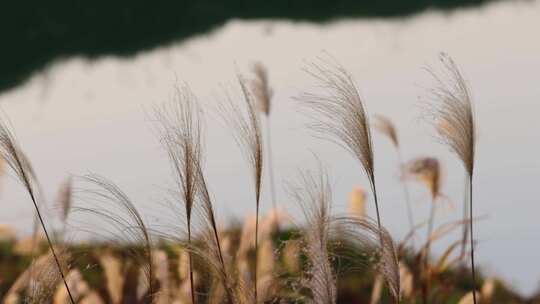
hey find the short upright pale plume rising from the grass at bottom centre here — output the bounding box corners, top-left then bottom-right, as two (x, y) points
(289, 166), (337, 304)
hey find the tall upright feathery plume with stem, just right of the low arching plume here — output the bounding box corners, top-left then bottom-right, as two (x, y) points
(156, 85), (202, 303)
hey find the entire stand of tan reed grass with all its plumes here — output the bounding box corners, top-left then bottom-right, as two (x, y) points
(0, 55), (502, 304)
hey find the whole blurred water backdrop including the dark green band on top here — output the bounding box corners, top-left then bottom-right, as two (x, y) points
(0, 0), (540, 295)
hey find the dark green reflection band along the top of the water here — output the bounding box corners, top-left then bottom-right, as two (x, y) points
(0, 0), (498, 91)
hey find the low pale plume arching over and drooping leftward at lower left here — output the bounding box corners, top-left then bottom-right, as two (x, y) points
(72, 174), (156, 301)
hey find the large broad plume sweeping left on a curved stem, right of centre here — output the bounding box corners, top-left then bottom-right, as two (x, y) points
(297, 60), (383, 243)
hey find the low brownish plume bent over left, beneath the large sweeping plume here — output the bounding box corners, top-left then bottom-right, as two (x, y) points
(332, 216), (400, 303)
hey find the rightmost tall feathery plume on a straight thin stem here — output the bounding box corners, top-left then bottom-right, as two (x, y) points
(428, 53), (477, 304)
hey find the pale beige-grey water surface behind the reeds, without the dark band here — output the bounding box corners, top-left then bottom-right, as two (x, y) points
(0, 1), (540, 292)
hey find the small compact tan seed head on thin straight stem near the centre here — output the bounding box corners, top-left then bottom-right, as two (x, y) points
(249, 62), (279, 230)
